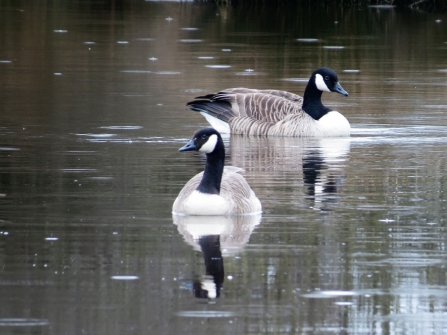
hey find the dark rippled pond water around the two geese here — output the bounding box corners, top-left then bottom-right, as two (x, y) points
(0, 1), (447, 335)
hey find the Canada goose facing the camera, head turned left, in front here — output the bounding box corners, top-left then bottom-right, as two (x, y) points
(172, 128), (262, 215)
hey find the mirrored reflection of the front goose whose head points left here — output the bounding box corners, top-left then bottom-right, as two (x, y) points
(173, 214), (261, 299)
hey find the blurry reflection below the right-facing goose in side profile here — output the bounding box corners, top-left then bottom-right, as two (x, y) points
(229, 136), (351, 210)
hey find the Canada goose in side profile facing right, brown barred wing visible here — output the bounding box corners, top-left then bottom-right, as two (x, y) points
(186, 67), (350, 137)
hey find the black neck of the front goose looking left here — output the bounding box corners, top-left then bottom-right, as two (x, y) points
(197, 139), (225, 194)
